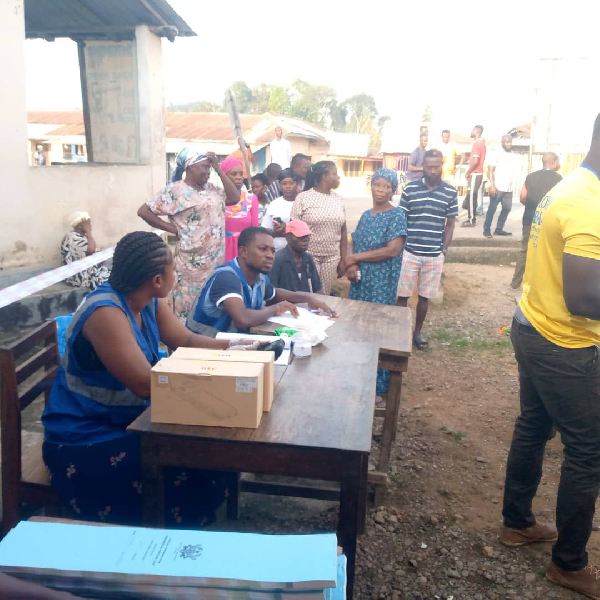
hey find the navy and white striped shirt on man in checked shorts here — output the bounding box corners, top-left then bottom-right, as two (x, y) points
(400, 179), (458, 256)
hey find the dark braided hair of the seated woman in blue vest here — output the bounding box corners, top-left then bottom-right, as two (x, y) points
(108, 231), (172, 293)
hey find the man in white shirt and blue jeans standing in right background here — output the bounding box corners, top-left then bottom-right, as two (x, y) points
(483, 135), (518, 238)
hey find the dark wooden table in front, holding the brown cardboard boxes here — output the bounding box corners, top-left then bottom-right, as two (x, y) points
(128, 340), (378, 598)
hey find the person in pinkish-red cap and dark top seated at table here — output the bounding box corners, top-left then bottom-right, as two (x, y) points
(269, 221), (321, 294)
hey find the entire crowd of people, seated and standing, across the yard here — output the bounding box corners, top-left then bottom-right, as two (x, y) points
(43, 115), (600, 598)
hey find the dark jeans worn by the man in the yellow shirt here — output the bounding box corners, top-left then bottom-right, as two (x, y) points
(502, 319), (600, 571)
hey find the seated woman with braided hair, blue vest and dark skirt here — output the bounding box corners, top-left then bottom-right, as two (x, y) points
(42, 231), (250, 527)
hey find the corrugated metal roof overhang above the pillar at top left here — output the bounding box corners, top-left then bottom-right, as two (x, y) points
(25, 0), (196, 39)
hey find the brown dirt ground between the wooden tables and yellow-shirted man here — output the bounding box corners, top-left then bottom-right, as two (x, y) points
(231, 264), (600, 600)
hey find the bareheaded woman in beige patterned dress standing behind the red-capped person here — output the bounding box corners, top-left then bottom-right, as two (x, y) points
(291, 160), (348, 295)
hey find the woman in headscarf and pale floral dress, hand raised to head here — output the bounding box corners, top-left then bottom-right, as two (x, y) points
(138, 148), (240, 322)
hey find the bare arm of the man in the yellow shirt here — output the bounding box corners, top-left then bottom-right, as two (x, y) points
(563, 252), (600, 321)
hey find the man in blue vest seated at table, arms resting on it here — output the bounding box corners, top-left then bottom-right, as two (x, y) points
(186, 227), (332, 337)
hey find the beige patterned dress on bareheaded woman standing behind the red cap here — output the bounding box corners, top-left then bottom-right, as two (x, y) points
(291, 189), (346, 295)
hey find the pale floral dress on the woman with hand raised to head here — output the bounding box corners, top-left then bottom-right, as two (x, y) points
(147, 181), (225, 322)
